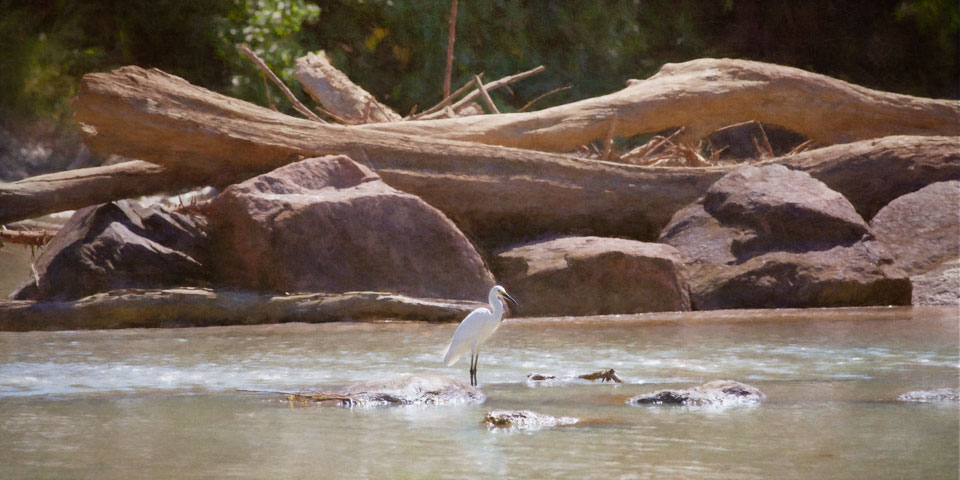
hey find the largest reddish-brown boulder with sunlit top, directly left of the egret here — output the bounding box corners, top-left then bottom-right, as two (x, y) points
(209, 156), (494, 300)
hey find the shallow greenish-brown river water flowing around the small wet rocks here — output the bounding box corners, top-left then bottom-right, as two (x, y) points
(0, 307), (960, 479)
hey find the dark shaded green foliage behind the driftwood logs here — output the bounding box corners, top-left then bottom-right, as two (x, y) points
(0, 0), (960, 181)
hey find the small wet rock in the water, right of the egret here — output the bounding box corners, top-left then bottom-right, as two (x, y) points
(627, 380), (766, 407)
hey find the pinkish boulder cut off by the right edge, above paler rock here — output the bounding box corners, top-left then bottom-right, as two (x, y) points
(870, 181), (960, 275)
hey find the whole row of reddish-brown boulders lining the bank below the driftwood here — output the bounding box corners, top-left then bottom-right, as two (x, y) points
(13, 149), (960, 316)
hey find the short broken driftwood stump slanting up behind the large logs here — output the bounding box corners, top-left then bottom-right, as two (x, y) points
(295, 53), (402, 124)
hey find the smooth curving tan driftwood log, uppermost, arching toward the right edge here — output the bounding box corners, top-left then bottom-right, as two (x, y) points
(361, 58), (960, 152)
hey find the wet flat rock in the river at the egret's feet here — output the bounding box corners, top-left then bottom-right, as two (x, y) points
(336, 373), (487, 407)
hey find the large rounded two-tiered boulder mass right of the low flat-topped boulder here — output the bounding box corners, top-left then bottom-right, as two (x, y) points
(660, 165), (911, 310)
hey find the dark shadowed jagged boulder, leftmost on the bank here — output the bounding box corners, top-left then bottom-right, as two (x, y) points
(12, 200), (209, 300)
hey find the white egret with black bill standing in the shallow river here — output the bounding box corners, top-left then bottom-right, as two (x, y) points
(443, 285), (520, 386)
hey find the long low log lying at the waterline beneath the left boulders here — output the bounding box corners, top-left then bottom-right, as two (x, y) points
(0, 288), (481, 332)
